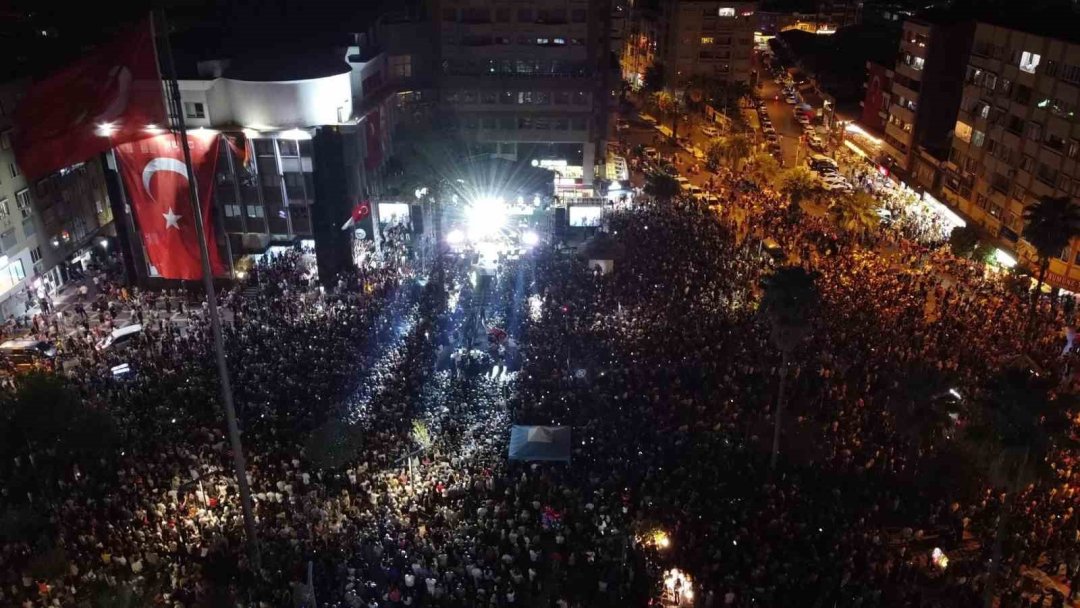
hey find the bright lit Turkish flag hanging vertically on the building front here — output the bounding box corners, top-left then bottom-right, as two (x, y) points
(117, 132), (225, 280)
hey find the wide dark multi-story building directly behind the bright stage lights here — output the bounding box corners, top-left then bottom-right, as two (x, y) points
(432, 0), (619, 190)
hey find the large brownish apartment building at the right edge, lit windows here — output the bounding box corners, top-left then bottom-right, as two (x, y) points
(943, 23), (1080, 292)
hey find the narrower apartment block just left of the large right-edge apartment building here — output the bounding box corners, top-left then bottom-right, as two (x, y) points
(882, 14), (974, 175)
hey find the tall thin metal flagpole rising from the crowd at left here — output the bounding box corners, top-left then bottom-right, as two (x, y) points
(151, 8), (260, 570)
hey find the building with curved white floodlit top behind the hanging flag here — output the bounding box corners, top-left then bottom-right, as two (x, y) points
(168, 44), (401, 257)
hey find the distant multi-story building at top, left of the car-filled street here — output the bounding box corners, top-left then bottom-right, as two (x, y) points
(660, 0), (757, 89)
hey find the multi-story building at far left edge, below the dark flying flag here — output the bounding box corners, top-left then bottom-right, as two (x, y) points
(0, 81), (112, 319)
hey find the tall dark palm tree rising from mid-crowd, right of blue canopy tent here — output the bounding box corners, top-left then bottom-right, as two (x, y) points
(760, 266), (820, 469)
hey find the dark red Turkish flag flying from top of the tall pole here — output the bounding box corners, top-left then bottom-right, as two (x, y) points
(12, 18), (167, 180)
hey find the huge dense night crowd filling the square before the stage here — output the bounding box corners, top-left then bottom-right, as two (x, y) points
(0, 124), (1080, 608)
